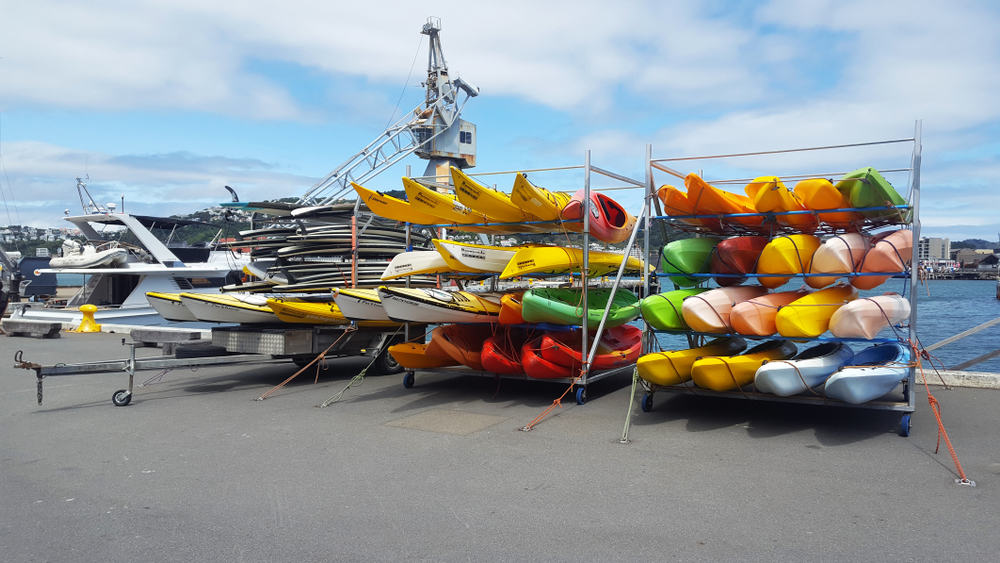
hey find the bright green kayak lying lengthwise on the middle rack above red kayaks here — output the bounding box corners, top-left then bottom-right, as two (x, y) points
(521, 288), (639, 328)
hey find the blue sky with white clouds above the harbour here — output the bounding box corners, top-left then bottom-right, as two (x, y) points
(0, 0), (1000, 240)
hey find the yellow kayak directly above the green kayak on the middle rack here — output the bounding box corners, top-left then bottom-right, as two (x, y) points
(500, 246), (643, 280)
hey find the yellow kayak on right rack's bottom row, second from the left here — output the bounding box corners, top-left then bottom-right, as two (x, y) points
(691, 340), (796, 391)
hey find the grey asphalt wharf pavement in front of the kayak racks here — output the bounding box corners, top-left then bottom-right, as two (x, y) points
(0, 334), (1000, 562)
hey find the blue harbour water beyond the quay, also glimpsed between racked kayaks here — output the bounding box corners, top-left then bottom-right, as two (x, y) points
(657, 279), (1000, 373)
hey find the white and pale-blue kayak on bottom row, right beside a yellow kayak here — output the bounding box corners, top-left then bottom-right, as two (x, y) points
(754, 342), (854, 397)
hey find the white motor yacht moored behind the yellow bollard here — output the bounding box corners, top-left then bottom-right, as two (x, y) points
(10, 179), (250, 326)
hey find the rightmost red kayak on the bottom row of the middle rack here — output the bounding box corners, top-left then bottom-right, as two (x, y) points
(541, 325), (642, 371)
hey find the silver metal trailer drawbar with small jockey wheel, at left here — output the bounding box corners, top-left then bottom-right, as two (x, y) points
(14, 338), (276, 407)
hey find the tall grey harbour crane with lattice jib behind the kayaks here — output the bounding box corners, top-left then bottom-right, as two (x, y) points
(298, 17), (479, 205)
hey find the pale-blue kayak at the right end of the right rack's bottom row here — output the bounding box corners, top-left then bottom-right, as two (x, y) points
(825, 343), (910, 405)
